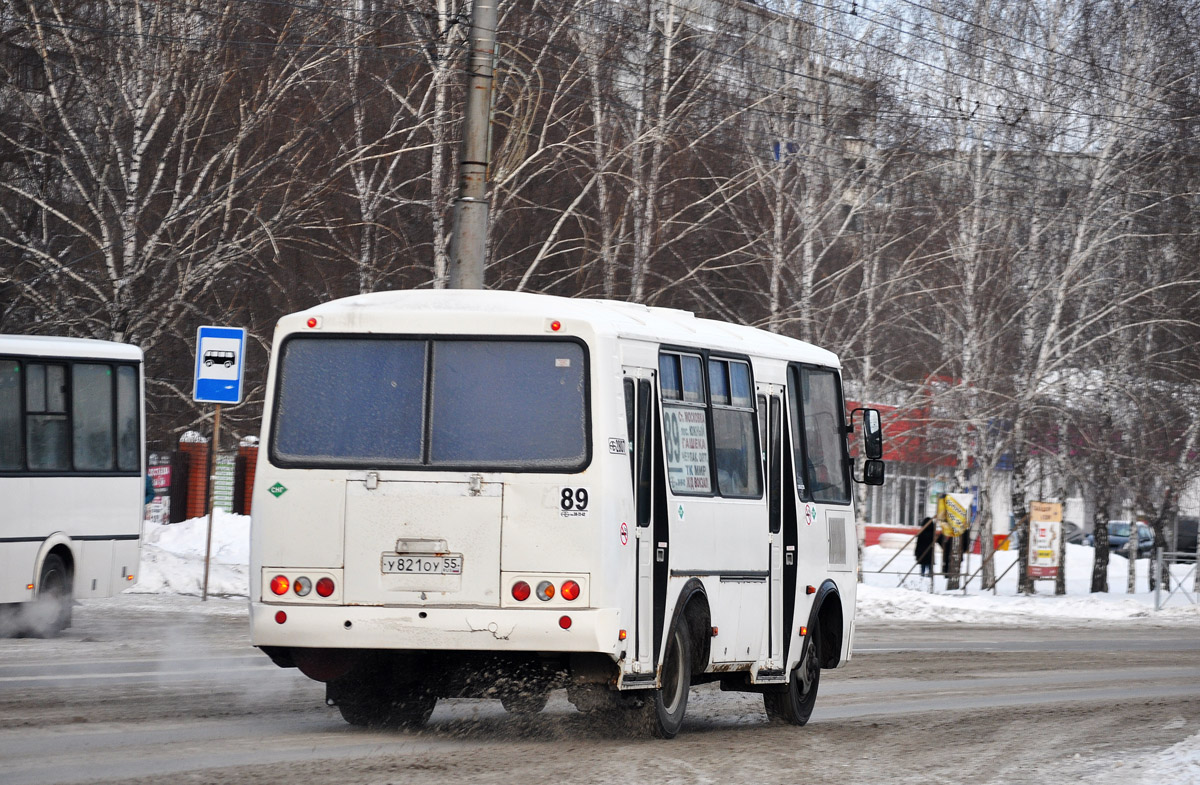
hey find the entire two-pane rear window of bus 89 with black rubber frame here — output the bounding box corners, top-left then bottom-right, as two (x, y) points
(271, 336), (589, 472)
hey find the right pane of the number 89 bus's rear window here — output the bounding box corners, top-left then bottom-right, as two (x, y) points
(430, 341), (588, 469)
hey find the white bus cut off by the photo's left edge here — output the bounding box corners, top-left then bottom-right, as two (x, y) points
(0, 335), (145, 635)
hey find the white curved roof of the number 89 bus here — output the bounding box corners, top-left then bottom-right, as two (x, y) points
(292, 289), (840, 367)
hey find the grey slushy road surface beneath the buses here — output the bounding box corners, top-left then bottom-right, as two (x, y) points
(0, 595), (1200, 785)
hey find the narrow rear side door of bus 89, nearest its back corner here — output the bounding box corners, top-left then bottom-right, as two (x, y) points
(624, 368), (665, 685)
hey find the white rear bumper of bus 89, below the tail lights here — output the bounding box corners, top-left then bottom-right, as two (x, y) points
(250, 603), (625, 657)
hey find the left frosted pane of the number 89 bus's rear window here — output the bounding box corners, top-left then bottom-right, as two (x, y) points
(272, 338), (425, 466)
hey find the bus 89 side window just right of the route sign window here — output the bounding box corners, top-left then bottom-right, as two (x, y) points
(708, 360), (762, 497)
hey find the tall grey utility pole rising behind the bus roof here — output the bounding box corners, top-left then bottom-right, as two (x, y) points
(450, 0), (498, 289)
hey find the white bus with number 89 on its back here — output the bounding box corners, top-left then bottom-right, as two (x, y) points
(250, 290), (883, 737)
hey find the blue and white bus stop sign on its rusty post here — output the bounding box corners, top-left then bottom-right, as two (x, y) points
(192, 325), (246, 603)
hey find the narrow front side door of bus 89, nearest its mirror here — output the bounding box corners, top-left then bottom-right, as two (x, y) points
(756, 384), (796, 682)
